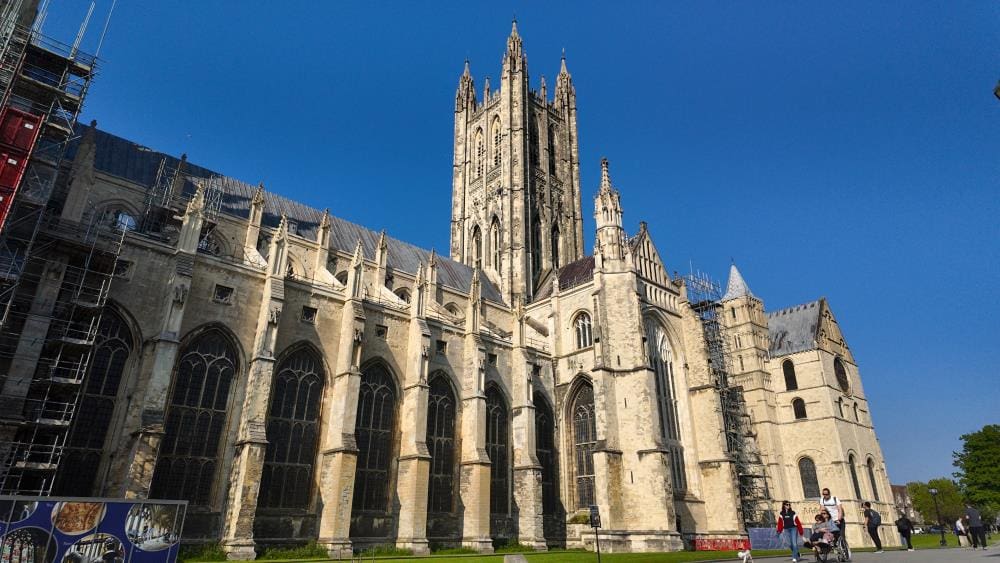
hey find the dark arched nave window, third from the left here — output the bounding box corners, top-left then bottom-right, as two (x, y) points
(257, 348), (325, 508)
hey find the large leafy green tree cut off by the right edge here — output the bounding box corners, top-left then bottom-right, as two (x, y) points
(953, 424), (1000, 516)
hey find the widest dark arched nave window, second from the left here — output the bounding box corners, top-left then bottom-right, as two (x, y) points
(149, 329), (237, 506)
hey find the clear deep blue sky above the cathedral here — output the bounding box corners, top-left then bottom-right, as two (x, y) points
(46, 0), (1000, 482)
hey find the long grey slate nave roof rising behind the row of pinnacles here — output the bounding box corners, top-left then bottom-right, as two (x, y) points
(66, 126), (503, 303)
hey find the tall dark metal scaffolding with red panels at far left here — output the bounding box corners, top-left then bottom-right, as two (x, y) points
(0, 1), (117, 495)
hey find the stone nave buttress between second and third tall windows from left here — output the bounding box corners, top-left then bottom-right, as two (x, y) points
(222, 217), (288, 559)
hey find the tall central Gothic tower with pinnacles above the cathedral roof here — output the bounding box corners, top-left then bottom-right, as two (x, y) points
(451, 21), (583, 304)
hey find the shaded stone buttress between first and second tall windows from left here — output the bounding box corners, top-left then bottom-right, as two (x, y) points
(122, 185), (205, 498)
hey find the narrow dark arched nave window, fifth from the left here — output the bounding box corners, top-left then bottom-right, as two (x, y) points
(427, 373), (455, 512)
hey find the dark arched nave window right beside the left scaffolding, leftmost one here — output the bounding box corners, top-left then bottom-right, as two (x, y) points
(53, 309), (132, 497)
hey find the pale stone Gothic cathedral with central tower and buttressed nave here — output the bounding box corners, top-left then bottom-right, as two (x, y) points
(4, 25), (894, 558)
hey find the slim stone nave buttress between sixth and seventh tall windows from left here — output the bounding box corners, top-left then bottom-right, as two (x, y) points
(511, 303), (547, 550)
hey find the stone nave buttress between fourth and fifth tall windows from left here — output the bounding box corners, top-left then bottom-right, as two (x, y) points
(396, 265), (431, 555)
